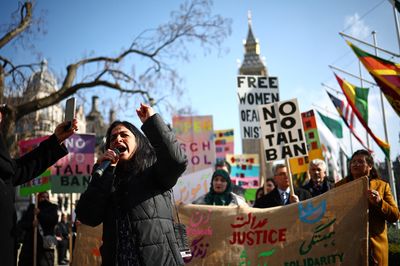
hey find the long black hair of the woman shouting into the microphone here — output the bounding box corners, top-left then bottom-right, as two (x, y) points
(105, 120), (156, 175)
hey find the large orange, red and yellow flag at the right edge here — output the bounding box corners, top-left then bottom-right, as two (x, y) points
(347, 41), (400, 116)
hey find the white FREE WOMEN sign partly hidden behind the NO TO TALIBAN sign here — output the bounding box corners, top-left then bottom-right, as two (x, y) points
(236, 75), (279, 139)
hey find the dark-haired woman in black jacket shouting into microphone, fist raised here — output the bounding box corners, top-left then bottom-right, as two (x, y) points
(76, 104), (187, 265)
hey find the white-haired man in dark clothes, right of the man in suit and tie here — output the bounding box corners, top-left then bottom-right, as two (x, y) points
(303, 159), (334, 197)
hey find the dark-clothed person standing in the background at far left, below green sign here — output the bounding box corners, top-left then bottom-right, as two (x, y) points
(18, 192), (58, 266)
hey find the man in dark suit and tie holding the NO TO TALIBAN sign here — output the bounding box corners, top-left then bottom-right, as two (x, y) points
(254, 164), (311, 208)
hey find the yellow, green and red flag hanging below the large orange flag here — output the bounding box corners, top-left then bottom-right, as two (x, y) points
(335, 74), (390, 157)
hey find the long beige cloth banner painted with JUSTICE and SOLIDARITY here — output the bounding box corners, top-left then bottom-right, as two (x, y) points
(74, 179), (368, 266)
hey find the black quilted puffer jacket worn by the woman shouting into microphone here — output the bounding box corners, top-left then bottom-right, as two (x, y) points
(76, 114), (187, 265)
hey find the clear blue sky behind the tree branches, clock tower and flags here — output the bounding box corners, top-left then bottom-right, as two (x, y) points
(0, 0), (400, 162)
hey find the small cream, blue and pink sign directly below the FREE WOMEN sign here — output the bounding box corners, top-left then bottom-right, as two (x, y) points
(226, 154), (260, 189)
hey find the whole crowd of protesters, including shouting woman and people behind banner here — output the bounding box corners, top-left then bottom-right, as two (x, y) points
(0, 104), (400, 266)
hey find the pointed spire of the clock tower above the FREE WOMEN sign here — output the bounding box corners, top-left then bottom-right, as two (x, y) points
(239, 10), (268, 75)
